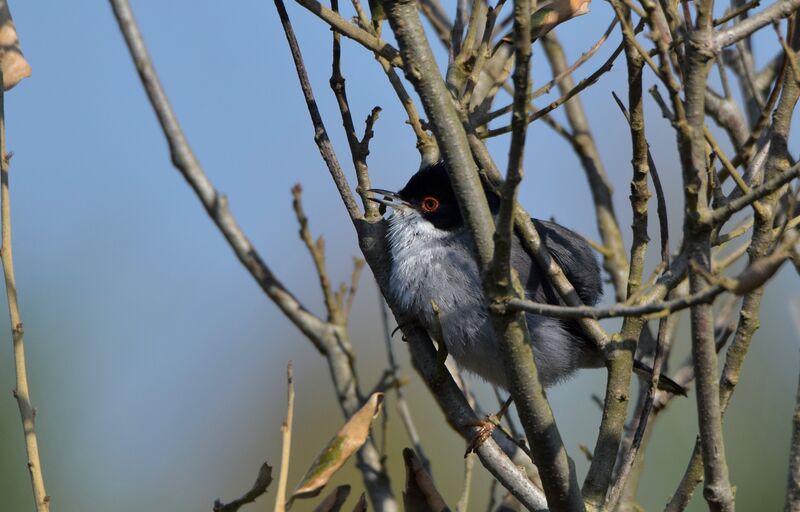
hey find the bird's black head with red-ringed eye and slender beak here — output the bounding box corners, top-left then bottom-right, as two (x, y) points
(374, 162), (500, 230)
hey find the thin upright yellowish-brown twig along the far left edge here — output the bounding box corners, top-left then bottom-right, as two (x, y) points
(0, 70), (50, 512)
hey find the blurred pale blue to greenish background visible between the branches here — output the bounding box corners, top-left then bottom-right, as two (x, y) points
(0, 0), (798, 512)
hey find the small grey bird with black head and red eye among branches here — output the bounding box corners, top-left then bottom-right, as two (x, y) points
(371, 162), (685, 394)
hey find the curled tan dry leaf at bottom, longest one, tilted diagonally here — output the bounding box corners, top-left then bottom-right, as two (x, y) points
(287, 393), (383, 508)
